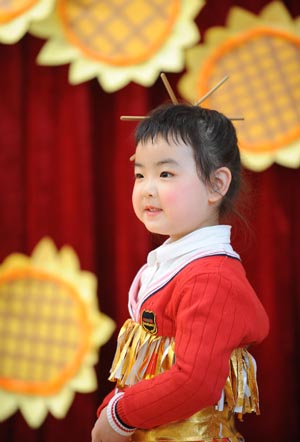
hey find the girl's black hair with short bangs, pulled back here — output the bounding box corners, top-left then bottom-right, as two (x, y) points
(135, 104), (241, 216)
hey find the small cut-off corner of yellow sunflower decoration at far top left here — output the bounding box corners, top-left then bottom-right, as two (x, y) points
(0, 0), (55, 43)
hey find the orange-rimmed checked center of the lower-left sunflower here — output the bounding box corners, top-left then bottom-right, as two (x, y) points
(0, 269), (89, 394)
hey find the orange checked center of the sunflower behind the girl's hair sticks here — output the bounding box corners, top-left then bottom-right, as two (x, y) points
(199, 29), (300, 151)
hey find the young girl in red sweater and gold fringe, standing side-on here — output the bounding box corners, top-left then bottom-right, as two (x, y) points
(92, 104), (269, 442)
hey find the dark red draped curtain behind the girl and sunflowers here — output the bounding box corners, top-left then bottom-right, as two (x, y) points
(0, 0), (300, 442)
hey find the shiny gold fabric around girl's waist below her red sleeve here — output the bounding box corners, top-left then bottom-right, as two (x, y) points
(131, 406), (244, 442)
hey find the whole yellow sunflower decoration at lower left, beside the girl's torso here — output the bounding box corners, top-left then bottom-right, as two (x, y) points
(0, 238), (114, 428)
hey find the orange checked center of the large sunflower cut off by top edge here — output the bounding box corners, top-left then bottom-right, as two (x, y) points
(59, 0), (180, 65)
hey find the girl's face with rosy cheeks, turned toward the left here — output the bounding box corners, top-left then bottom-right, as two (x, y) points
(132, 137), (218, 240)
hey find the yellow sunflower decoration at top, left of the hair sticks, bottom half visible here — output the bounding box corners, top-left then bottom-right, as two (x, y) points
(30, 0), (204, 92)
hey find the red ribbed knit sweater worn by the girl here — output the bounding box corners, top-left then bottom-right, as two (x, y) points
(100, 256), (269, 429)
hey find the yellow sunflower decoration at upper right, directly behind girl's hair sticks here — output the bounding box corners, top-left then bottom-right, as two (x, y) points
(178, 2), (300, 171)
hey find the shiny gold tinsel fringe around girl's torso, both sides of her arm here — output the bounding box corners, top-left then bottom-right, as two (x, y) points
(109, 319), (260, 420)
